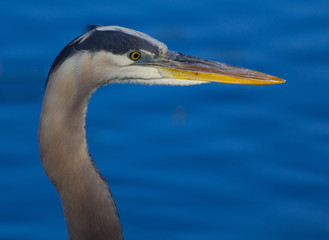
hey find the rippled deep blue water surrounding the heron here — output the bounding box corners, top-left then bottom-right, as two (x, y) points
(0, 0), (329, 240)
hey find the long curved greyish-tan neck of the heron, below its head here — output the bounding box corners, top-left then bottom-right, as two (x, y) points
(38, 58), (123, 240)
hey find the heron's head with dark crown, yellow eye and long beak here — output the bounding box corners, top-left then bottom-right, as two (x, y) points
(50, 26), (284, 89)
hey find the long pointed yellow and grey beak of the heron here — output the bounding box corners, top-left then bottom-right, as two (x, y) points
(156, 51), (285, 85)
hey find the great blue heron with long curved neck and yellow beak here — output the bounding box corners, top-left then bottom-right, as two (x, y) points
(38, 26), (284, 240)
